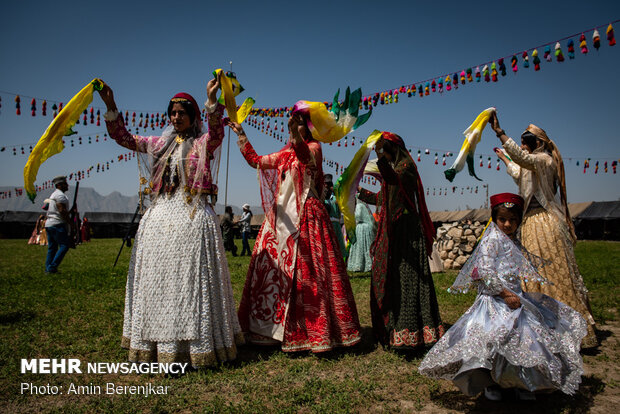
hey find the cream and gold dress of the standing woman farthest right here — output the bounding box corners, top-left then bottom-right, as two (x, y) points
(504, 127), (598, 347)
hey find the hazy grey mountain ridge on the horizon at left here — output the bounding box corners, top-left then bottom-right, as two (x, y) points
(0, 186), (263, 215)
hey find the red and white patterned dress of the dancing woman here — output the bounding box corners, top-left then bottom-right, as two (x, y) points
(239, 133), (361, 352)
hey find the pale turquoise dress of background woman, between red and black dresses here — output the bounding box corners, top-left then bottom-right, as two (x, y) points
(347, 201), (377, 272)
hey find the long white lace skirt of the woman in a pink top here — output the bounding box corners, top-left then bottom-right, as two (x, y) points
(122, 146), (243, 367)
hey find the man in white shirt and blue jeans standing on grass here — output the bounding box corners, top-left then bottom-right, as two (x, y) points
(45, 176), (71, 273)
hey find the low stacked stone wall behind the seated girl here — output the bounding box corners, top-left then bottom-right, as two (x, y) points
(437, 220), (486, 270)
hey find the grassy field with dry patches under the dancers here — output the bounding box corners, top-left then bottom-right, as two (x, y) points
(0, 239), (620, 413)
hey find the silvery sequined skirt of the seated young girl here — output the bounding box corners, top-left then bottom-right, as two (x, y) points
(418, 293), (586, 395)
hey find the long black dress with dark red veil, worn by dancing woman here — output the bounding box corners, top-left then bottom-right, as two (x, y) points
(359, 132), (444, 348)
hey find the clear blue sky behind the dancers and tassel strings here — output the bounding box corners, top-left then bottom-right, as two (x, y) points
(0, 1), (620, 210)
